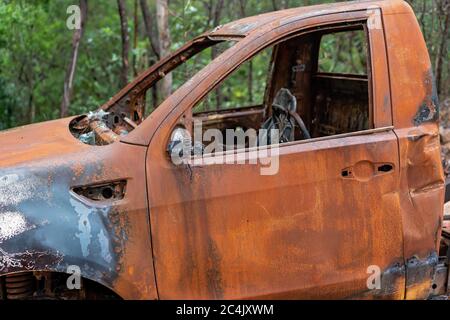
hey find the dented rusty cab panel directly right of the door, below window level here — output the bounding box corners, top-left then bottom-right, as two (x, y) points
(396, 123), (444, 299)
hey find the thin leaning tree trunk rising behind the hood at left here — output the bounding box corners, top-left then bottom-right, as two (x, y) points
(60, 0), (87, 117)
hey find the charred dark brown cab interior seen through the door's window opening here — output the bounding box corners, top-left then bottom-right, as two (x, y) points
(194, 24), (373, 146)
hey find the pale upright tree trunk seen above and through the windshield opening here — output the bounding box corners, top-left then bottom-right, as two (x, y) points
(156, 0), (172, 99)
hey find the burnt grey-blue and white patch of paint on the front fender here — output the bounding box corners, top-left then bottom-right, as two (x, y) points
(0, 164), (120, 287)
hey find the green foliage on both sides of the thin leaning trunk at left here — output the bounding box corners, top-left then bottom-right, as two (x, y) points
(0, 0), (125, 129)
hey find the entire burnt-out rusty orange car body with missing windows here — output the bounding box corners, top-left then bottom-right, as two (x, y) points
(0, 1), (448, 299)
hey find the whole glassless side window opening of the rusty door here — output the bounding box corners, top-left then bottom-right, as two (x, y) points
(181, 23), (373, 154)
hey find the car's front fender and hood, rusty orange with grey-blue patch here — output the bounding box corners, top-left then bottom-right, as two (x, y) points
(0, 118), (157, 299)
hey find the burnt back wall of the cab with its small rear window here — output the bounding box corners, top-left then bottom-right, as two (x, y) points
(311, 26), (373, 137)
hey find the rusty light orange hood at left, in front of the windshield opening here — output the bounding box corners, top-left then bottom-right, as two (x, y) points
(0, 117), (89, 167)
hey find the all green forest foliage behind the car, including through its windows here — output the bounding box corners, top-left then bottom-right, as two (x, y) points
(0, 0), (450, 129)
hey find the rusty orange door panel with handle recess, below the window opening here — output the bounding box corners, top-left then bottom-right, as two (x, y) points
(147, 132), (404, 299)
